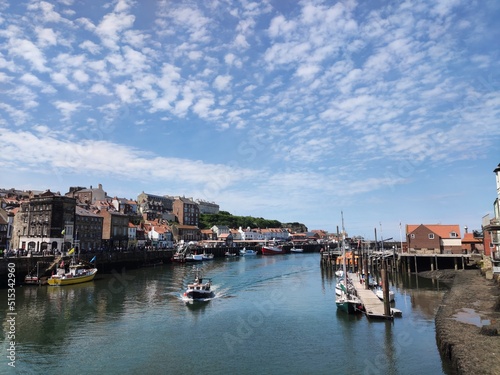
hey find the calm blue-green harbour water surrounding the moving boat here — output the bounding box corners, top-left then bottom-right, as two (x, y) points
(0, 253), (454, 375)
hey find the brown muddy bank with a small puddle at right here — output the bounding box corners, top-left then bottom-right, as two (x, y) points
(428, 270), (500, 375)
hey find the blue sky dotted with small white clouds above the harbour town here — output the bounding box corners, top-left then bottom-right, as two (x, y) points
(0, 0), (500, 241)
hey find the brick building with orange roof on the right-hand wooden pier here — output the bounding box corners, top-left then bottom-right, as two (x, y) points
(406, 224), (462, 254)
